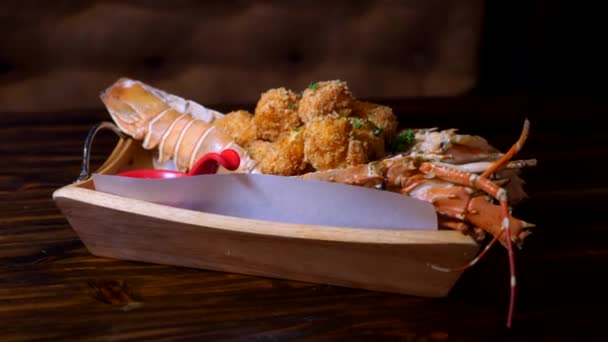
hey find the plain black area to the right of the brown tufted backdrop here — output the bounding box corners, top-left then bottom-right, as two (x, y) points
(474, 0), (607, 97)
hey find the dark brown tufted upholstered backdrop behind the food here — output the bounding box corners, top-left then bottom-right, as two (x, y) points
(0, 0), (483, 111)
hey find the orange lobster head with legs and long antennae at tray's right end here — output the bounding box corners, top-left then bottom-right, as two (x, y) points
(301, 120), (536, 327)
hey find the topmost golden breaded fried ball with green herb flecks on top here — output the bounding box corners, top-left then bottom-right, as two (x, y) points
(298, 80), (354, 123)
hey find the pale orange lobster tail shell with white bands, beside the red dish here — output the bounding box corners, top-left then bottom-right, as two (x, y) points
(100, 78), (254, 172)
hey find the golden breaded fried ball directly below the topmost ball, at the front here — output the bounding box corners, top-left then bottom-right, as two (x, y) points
(304, 114), (352, 170)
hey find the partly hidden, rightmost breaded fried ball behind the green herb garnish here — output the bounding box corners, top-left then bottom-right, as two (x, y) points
(353, 101), (398, 143)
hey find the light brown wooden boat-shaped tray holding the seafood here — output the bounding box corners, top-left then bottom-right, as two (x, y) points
(53, 130), (479, 297)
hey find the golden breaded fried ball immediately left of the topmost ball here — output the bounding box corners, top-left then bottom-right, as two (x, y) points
(253, 87), (302, 141)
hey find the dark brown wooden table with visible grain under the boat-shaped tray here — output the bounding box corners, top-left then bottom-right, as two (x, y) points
(0, 98), (608, 341)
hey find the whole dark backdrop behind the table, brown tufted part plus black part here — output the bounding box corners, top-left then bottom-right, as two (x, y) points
(0, 0), (604, 112)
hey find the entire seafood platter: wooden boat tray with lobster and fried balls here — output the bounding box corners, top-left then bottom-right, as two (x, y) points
(53, 78), (536, 325)
